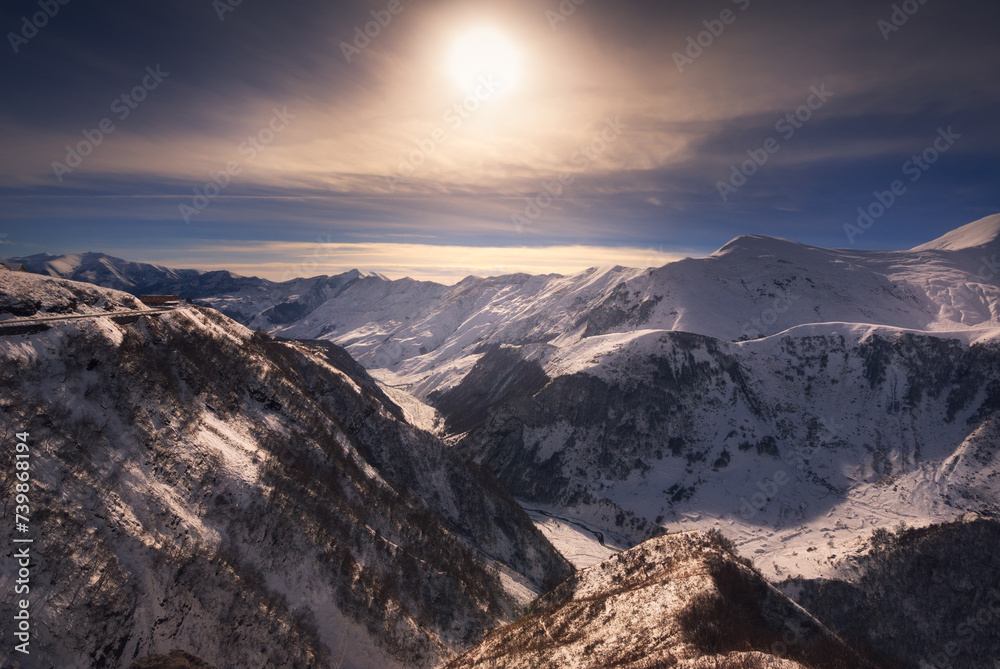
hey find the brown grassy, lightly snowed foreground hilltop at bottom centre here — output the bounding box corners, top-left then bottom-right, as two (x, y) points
(448, 532), (874, 669)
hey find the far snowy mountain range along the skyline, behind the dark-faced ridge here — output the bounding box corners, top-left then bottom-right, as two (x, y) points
(176, 216), (1000, 398)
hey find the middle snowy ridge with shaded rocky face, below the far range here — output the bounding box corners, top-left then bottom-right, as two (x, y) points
(448, 326), (1000, 578)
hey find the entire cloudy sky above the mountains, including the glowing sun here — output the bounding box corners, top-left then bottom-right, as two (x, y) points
(0, 0), (1000, 283)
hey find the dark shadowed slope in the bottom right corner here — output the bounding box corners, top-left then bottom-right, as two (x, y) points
(782, 518), (1000, 669)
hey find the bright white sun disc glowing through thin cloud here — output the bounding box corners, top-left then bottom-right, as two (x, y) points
(449, 28), (521, 92)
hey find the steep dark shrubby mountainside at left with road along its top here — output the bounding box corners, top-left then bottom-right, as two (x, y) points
(0, 271), (572, 668)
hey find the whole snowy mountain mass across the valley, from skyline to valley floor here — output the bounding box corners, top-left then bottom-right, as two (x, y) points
(13, 215), (1000, 577)
